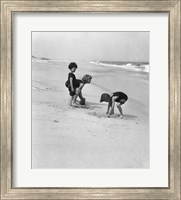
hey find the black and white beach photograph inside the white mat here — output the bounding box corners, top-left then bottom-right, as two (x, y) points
(31, 31), (150, 169)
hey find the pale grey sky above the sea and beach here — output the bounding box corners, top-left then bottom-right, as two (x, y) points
(32, 32), (150, 62)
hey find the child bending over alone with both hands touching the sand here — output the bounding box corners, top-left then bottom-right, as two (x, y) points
(100, 92), (128, 118)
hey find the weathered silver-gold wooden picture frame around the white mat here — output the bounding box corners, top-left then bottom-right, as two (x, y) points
(0, 0), (181, 200)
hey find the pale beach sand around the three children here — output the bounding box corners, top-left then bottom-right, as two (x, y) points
(32, 61), (150, 169)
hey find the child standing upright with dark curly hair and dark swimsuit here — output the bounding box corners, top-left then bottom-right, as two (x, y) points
(67, 62), (77, 106)
